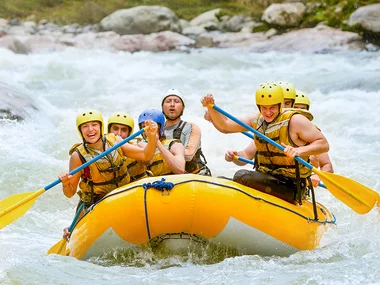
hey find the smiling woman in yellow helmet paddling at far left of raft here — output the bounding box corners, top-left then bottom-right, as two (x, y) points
(59, 110), (157, 208)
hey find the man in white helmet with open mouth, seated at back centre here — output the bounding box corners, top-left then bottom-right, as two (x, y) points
(161, 89), (211, 176)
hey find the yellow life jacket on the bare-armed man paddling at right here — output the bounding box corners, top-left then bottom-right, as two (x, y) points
(253, 110), (311, 179)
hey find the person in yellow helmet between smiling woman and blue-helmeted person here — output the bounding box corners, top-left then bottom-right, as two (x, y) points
(107, 112), (150, 182)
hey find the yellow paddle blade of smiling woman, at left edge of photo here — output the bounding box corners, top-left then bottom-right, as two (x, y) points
(0, 189), (45, 229)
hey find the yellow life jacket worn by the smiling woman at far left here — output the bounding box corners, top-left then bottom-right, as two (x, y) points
(69, 134), (130, 204)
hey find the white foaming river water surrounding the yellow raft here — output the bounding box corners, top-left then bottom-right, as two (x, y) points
(0, 48), (380, 284)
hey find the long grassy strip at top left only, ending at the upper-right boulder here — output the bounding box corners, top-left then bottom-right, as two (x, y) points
(0, 0), (276, 25)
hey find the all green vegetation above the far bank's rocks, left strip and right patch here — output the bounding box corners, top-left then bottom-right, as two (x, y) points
(0, 0), (379, 35)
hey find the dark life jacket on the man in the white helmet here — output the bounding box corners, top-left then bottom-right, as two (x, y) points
(173, 120), (211, 176)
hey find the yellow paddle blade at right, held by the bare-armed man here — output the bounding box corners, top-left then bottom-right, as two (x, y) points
(313, 168), (379, 214)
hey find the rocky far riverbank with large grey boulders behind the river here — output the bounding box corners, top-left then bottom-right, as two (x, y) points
(0, 2), (380, 54)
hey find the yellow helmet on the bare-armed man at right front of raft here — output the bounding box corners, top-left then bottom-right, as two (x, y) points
(256, 82), (284, 112)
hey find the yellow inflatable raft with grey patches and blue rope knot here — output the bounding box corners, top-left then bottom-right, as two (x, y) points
(58, 174), (335, 259)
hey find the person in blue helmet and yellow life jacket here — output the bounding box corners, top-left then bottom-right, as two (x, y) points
(138, 109), (186, 176)
